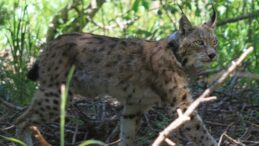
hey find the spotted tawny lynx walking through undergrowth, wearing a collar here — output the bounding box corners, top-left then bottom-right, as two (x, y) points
(16, 11), (217, 146)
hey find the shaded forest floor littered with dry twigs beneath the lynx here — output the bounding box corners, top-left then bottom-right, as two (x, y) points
(0, 77), (259, 146)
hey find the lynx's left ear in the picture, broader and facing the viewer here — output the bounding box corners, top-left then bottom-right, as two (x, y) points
(179, 14), (192, 35)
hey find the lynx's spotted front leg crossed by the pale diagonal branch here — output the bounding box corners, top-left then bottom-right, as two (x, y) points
(152, 61), (217, 146)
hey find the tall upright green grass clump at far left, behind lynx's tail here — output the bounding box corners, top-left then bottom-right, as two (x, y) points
(0, 3), (38, 104)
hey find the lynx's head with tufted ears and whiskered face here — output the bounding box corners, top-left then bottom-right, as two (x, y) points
(168, 10), (217, 69)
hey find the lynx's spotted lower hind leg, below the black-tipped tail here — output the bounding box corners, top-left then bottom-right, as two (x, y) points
(15, 87), (60, 145)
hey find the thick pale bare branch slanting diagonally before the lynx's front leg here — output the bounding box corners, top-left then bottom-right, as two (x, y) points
(152, 47), (253, 146)
